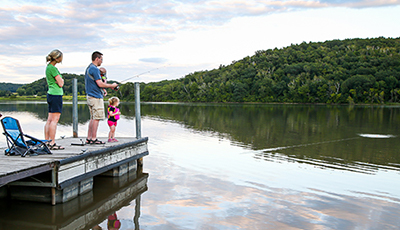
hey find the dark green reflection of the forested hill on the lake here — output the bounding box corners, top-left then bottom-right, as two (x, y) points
(142, 104), (400, 170)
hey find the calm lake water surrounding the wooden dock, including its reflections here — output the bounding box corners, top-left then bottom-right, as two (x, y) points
(0, 102), (400, 229)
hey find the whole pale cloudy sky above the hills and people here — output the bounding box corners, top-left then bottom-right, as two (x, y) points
(0, 0), (400, 83)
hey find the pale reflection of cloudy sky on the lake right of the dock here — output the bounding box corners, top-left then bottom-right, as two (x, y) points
(145, 136), (400, 229)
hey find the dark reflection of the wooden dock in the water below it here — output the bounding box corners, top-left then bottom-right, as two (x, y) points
(0, 173), (148, 230)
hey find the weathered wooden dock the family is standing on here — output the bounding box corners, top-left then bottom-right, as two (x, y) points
(0, 137), (149, 205)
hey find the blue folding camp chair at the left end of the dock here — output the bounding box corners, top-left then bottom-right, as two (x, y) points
(1, 117), (51, 157)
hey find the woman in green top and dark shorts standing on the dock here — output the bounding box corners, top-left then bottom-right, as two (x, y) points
(44, 50), (64, 150)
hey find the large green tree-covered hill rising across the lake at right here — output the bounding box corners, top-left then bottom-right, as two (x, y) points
(129, 37), (400, 103)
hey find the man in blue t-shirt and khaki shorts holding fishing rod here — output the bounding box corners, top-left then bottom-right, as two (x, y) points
(85, 51), (118, 144)
